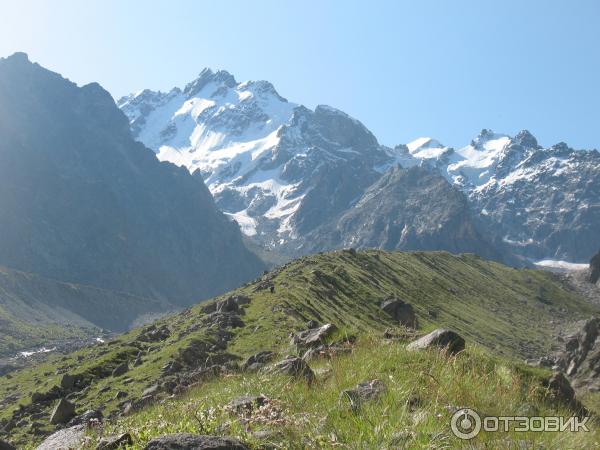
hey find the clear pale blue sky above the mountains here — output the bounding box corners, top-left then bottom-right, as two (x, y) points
(0, 0), (600, 148)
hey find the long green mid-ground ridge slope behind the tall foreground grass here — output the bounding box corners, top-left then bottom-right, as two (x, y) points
(0, 251), (598, 442)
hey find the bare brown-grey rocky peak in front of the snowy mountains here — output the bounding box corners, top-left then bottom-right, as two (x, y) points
(302, 166), (502, 259)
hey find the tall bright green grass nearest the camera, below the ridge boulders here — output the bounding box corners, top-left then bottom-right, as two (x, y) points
(90, 336), (600, 449)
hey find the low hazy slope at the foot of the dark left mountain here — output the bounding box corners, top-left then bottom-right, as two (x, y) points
(0, 266), (173, 357)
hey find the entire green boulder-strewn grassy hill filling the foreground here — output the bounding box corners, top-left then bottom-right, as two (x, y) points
(0, 251), (598, 448)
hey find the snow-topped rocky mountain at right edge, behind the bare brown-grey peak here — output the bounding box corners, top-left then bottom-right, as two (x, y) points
(405, 130), (600, 262)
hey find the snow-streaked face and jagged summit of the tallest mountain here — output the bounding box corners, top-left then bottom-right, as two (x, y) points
(118, 69), (391, 250)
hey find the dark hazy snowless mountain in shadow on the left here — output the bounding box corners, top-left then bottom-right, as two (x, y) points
(0, 53), (262, 305)
